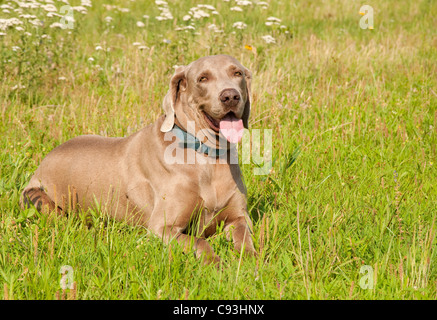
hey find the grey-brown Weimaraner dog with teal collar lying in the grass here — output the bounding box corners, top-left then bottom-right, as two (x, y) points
(21, 55), (255, 263)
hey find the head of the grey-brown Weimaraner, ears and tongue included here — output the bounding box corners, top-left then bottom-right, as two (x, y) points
(161, 55), (251, 144)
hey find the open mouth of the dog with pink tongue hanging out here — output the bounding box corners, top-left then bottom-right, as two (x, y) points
(203, 111), (244, 143)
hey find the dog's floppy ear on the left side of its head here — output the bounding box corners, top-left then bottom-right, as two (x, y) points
(161, 66), (186, 132)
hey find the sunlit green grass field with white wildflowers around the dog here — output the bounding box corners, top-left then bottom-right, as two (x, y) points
(0, 0), (437, 299)
